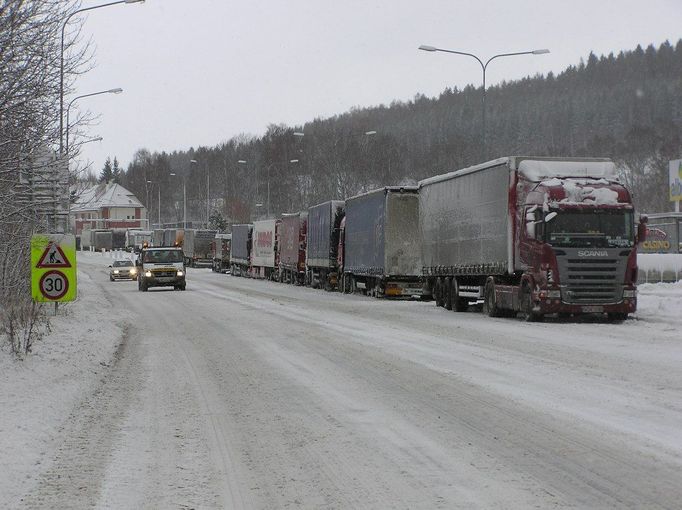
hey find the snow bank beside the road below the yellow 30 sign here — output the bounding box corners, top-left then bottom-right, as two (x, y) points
(0, 255), (124, 508)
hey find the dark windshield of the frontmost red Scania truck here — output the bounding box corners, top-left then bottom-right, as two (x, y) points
(545, 209), (635, 248)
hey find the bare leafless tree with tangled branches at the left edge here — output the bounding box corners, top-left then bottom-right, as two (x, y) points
(0, 0), (87, 353)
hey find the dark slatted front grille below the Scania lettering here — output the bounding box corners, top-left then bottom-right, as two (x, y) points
(555, 249), (627, 304)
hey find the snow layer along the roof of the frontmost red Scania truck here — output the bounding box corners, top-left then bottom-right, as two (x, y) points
(418, 156), (618, 188)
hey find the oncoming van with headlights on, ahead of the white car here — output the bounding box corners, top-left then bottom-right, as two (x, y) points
(137, 247), (186, 292)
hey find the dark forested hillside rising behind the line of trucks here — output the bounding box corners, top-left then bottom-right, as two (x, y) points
(122, 40), (682, 227)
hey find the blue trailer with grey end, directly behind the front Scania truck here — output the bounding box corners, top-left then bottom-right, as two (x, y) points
(339, 186), (428, 297)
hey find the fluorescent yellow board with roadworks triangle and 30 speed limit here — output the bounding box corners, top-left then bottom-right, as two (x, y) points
(31, 234), (77, 302)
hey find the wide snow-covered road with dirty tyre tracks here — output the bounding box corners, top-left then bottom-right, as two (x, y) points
(13, 253), (682, 509)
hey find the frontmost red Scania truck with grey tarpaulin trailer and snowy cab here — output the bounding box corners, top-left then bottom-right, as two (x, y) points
(419, 156), (646, 321)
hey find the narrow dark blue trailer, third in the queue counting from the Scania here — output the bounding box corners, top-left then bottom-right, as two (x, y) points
(305, 200), (344, 290)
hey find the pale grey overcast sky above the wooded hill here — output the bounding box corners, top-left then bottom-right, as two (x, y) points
(71, 0), (682, 173)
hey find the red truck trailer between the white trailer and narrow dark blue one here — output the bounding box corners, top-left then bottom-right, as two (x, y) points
(277, 211), (308, 285)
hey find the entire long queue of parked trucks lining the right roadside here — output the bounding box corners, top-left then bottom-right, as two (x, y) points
(130, 156), (646, 321)
